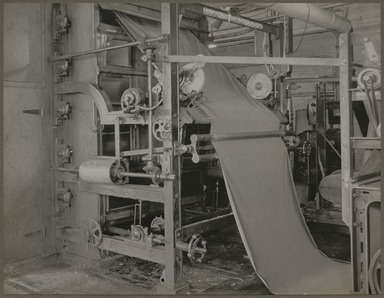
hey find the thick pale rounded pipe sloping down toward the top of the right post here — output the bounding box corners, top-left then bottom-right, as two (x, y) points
(257, 3), (352, 33)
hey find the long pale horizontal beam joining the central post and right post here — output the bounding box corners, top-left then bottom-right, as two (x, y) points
(164, 55), (347, 66)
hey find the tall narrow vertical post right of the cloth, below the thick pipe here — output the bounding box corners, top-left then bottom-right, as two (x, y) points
(339, 32), (356, 288)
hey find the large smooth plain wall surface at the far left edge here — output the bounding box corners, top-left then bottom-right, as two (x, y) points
(3, 3), (52, 262)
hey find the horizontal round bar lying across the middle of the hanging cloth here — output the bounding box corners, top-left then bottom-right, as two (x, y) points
(190, 131), (293, 142)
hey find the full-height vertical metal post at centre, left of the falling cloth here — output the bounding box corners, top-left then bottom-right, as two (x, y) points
(161, 3), (183, 292)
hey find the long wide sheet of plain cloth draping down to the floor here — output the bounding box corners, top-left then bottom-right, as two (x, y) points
(116, 13), (352, 294)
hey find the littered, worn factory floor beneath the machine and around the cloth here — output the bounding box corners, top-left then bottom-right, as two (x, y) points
(4, 224), (349, 295)
